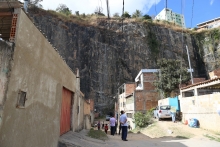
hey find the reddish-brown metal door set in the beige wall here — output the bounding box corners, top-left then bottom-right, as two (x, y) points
(60, 88), (72, 135)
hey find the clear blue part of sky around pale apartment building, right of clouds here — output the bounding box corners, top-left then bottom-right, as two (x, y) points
(147, 0), (220, 28)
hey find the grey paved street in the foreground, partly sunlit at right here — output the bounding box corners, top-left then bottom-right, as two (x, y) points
(59, 130), (220, 147)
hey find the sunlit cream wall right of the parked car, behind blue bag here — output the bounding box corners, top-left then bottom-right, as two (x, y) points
(180, 93), (220, 132)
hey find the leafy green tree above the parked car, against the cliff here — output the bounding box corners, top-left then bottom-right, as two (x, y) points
(154, 58), (190, 97)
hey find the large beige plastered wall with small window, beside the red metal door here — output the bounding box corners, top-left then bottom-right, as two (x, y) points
(0, 10), (77, 147)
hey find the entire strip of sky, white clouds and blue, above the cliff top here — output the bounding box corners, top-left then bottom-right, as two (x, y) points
(41, 0), (220, 28)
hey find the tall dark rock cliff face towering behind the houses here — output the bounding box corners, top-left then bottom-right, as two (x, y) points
(29, 8), (205, 108)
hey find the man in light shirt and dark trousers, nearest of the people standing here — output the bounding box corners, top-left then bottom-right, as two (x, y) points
(120, 110), (128, 141)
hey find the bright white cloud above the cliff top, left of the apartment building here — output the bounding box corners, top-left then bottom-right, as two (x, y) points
(38, 0), (161, 15)
